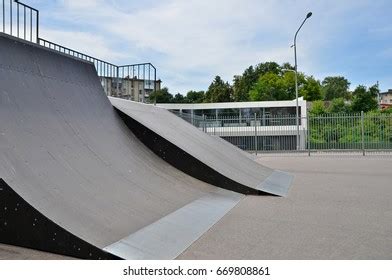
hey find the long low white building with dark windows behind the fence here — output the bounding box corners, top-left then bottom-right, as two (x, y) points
(156, 98), (307, 150)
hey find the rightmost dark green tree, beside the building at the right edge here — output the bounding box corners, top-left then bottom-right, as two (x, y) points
(351, 84), (380, 112)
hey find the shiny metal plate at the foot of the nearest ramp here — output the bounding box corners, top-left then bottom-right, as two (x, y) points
(104, 190), (243, 260)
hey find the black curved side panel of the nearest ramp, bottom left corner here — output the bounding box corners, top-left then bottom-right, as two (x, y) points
(0, 178), (121, 260)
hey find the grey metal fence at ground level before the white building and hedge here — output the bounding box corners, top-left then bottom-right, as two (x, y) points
(174, 112), (392, 153)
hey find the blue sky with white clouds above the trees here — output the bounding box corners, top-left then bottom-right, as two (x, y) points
(22, 0), (392, 94)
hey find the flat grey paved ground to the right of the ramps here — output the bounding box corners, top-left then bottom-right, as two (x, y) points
(179, 155), (392, 259)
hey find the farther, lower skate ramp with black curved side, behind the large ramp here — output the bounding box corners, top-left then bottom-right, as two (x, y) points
(110, 97), (292, 196)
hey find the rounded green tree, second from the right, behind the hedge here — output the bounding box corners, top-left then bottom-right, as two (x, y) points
(322, 76), (350, 100)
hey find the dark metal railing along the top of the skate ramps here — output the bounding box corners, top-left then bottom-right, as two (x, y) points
(0, 0), (157, 101)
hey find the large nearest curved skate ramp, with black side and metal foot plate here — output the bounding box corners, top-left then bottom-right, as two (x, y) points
(0, 34), (242, 259)
